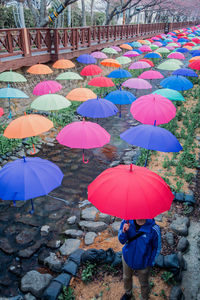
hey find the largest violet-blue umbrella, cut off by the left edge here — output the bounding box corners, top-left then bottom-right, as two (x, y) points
(0, 157), (63, 213)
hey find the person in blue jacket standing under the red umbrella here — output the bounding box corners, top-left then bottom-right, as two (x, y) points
(118, 219), (161, 300)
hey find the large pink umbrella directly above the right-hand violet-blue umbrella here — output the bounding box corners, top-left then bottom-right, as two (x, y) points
(130, 94), (176, 125)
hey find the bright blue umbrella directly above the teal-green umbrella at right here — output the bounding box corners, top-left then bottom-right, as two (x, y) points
(160, 76), (193, 91)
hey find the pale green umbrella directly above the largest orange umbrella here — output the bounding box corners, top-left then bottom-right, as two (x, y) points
(31, 94), (71, 111)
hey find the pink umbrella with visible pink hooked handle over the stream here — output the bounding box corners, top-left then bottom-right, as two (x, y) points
(56, 120), (110, 163)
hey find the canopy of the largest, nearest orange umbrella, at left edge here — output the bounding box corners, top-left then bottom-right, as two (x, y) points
(3, 114), (53, 139)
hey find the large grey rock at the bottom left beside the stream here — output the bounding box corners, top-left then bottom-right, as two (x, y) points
(21, 270), (52, 297)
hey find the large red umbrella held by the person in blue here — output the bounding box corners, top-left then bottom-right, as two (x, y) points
(88, 165), (174, 220)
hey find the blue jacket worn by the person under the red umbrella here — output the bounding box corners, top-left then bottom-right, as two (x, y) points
(118, 219), (161, 270)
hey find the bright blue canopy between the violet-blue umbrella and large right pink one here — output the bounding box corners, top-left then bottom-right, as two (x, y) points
(105, 89), (136, 105)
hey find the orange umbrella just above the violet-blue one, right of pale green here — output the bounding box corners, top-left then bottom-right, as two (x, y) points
(66, 88), (97, 101)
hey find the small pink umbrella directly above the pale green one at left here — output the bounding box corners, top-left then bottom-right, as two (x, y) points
(33, 80), (62, 96)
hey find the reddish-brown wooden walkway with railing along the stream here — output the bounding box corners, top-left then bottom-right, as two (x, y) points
(0, 22), (198, 72)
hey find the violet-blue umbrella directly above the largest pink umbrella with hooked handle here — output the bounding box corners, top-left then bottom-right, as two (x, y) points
(77, 98), (118, 118)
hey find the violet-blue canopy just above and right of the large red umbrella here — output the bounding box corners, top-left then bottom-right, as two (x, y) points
(120, 125), (182, 152)
